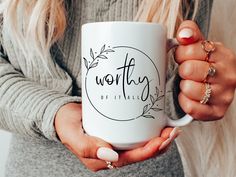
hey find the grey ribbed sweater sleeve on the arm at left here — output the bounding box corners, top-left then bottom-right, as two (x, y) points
(0, 46), (81, 141)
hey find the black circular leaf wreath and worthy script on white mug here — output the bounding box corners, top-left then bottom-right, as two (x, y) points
(83, 44), (164, 121)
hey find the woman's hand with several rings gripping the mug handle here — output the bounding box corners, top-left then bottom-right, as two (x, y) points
(175, 21), (236, 120)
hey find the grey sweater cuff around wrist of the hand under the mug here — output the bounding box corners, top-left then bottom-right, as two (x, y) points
(42, 95), (81, 142)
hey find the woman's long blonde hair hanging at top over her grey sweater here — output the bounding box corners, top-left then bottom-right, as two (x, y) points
(0, 0), (198, 67)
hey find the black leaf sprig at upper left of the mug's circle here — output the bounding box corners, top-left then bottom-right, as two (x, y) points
(83, 44), (115, 73)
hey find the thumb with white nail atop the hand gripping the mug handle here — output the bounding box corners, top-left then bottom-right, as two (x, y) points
(177, 20), (204, 45)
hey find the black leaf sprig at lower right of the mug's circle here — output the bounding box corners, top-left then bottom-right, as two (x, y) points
(140, 87), (164, 119)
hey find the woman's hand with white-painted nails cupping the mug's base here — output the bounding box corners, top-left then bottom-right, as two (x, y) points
(55, 103), (180, 171)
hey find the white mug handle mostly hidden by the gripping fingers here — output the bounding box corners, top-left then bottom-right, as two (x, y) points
(164, 38), (193, 127)
